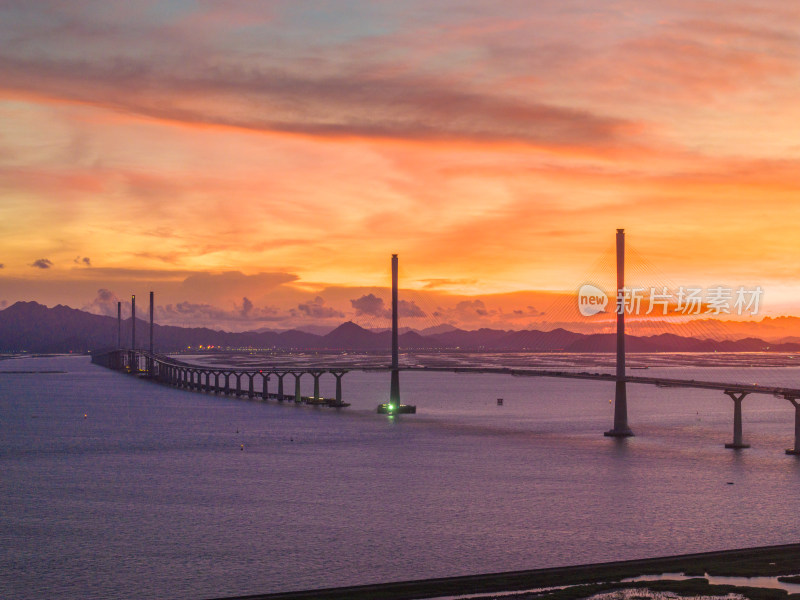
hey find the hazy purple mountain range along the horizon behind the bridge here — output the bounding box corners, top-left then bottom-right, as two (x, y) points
(0, 302), (800, 352)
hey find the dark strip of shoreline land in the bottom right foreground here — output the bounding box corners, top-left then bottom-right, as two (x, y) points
(208, 544), (800, 600)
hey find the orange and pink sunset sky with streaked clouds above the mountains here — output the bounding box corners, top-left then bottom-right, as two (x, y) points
(0, 0), (800, 329)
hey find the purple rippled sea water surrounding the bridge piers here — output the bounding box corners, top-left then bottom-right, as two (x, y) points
(0, 357), (800, 599)
